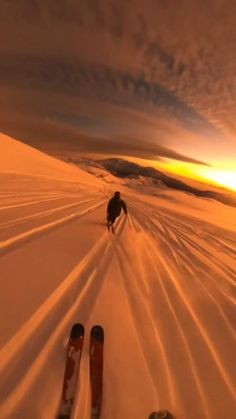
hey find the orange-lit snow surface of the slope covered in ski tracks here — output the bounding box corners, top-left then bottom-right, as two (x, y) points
(0, 135), (236, 419)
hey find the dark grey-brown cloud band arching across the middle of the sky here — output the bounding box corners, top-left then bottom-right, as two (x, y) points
(0, 55), (225, 136)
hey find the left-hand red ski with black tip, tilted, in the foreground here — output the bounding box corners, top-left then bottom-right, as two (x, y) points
(57, 323), (84, 419)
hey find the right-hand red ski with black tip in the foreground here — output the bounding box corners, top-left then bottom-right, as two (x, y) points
(89, 325), (104, 419)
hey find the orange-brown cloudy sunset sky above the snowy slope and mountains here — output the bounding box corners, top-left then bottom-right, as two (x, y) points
(0, 0), (236, 190)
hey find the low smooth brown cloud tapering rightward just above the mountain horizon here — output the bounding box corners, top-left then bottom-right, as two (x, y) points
(0, 107), (206, 165)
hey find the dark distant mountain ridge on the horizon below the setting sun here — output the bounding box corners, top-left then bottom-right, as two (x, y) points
(97, 158), (236, 206)
